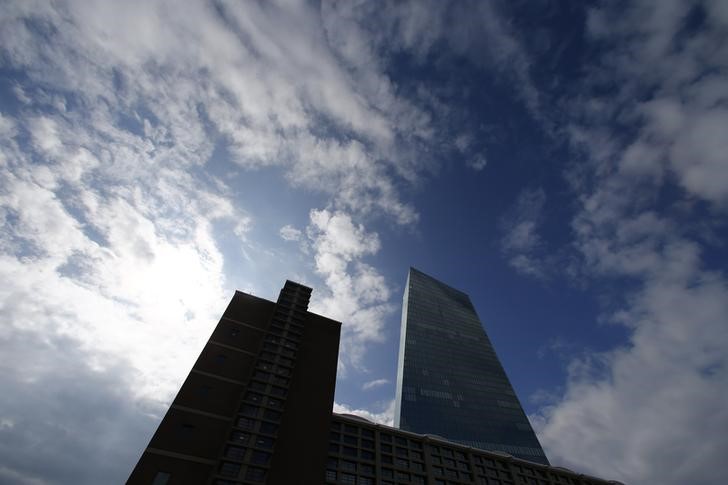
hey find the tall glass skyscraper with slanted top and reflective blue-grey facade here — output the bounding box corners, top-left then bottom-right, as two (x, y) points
(394, 268), (548, 464)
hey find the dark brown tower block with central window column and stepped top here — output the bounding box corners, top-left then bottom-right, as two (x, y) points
(127, 281), (341, 485)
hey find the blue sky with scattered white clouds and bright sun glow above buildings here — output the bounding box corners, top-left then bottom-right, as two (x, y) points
(0, 0), (728, 485)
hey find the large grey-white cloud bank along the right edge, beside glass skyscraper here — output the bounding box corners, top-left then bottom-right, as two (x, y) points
(532, 2), (728, 484)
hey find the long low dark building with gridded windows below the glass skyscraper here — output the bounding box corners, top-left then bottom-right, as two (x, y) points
(328, 414), (619, 485)
